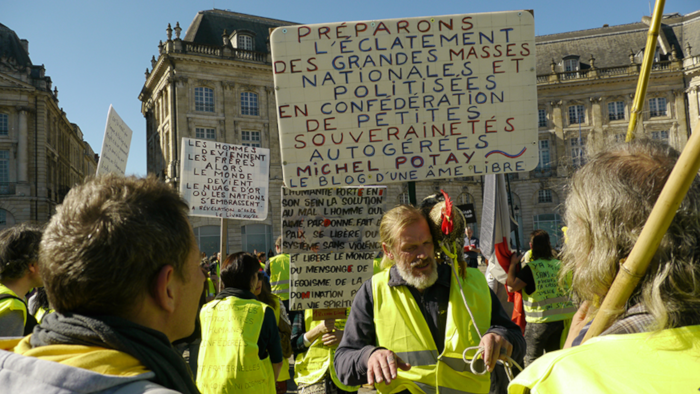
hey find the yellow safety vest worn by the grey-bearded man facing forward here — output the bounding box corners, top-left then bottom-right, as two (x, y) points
(372, 268), (491, 394)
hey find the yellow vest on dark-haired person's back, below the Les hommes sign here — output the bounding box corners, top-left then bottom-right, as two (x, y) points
(197, 296), (275, 394)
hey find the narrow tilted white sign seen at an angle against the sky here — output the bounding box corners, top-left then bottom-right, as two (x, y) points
(97, 104), (133, 175)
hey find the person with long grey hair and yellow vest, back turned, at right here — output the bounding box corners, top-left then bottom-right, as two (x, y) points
(509, 140), (700, 393)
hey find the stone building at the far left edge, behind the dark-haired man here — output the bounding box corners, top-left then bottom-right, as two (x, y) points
(0, 24), (97, 229)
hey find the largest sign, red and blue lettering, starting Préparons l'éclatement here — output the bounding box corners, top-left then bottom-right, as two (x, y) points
(270, 11), (538, 188)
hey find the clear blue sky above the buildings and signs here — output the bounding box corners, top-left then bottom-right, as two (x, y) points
(0, 0), (700, 175)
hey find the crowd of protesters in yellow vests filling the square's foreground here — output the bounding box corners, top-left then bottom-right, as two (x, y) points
(0, 140), (700, 394)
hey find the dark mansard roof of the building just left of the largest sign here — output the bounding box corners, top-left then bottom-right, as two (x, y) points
(183, 9), (297, 52)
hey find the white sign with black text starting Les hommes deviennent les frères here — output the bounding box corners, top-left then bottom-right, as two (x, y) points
(180, 138), (270, 220)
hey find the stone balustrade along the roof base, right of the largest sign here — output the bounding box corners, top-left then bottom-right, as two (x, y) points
(537, 56), (684, 84)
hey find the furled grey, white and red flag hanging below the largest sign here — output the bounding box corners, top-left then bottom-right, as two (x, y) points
(481, 174), (525, 332)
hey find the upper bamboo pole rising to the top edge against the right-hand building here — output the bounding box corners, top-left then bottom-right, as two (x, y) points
(625, 0), (666, 142)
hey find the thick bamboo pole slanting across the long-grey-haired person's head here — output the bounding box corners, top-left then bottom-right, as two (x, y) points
(583, 116), (700, 342)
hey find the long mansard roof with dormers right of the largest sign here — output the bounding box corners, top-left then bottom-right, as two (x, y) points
(535, 11), (700, 75)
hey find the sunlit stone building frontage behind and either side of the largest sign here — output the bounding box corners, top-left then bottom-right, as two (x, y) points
(140, 10), (700, 253)
